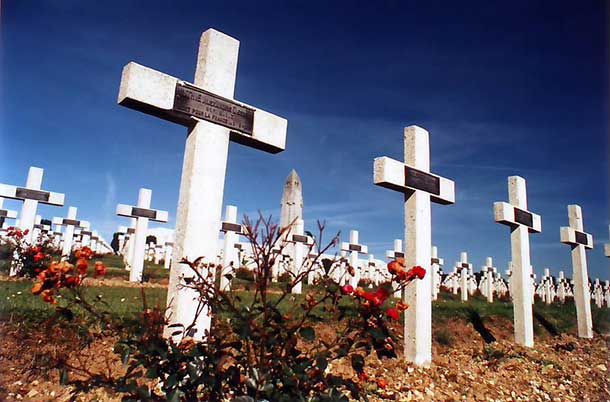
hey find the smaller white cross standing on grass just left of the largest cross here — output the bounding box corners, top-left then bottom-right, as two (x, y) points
(116, 188), (168, 282)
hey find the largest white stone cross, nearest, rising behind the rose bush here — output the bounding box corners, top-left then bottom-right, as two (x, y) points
(118, 29), (288, 339)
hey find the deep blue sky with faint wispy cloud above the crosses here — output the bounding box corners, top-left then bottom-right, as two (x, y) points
(0, 0), (610, 278)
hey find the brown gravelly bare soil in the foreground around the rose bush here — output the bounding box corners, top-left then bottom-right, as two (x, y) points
(0, 317), (610, 402)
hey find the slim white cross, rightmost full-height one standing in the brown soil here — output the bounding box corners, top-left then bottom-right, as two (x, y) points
(560, 205), (593, 338)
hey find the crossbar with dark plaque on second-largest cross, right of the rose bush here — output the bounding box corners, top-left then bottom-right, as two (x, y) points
(373, 156), (455, 205)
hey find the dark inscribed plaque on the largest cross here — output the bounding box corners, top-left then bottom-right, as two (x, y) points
(174, 83), (254, 135)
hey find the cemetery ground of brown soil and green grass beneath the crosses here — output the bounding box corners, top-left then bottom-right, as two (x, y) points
(0, 280), (610, 401)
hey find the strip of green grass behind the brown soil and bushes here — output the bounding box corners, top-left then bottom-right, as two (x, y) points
(0, 278), (610, 342)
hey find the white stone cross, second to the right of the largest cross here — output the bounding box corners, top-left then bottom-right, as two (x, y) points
(494, 176), (542, 347)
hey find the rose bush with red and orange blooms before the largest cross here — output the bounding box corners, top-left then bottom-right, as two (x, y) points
(26, 217), (425, 402)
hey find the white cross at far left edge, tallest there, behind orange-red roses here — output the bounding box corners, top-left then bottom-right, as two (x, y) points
(0, 166), (64, 243)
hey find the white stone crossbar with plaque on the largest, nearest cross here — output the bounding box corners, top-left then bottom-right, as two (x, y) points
(118, 62), (288, 153)
